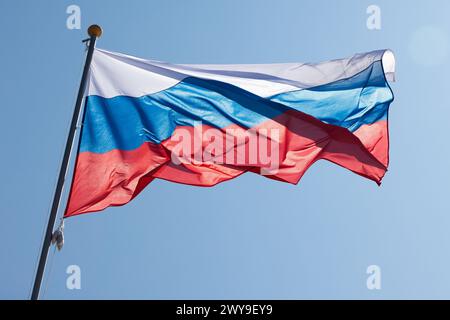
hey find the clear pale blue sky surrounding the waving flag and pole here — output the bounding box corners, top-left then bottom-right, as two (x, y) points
(0, 0), (450, 299)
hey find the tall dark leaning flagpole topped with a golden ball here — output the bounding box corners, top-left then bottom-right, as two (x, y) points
(31, 25), (102, 300)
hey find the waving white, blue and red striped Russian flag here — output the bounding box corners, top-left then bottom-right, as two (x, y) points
(65, 49), (395, 217)
